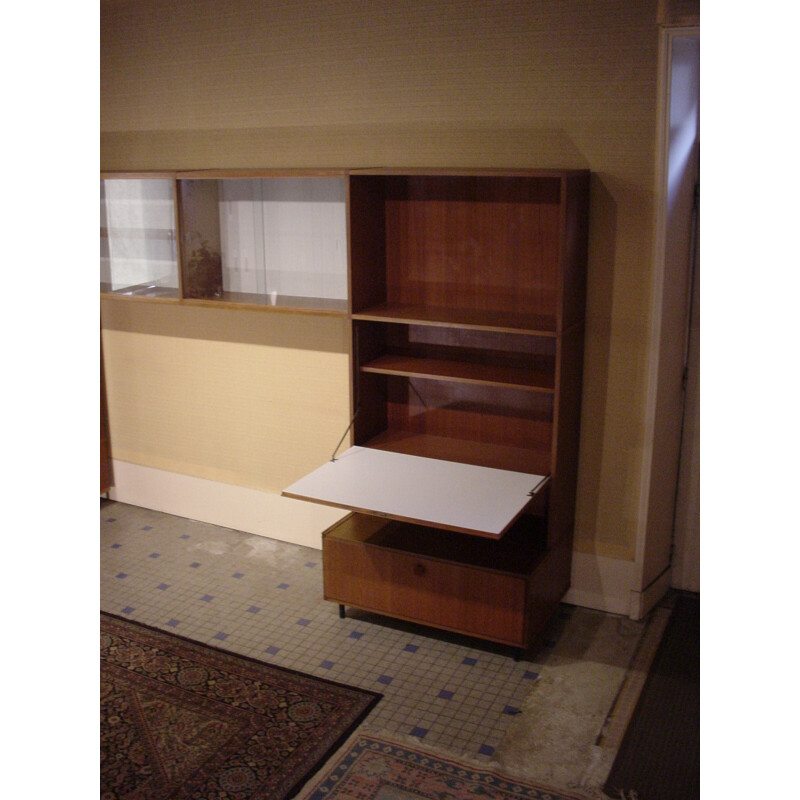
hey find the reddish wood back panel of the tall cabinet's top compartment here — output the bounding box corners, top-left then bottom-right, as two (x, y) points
(386, 176), (560, 314)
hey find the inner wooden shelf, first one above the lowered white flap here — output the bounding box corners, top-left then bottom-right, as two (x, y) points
(361, 354), (555, 394)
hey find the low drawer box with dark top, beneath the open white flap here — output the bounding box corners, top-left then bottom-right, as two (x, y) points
(322, 514), (538, 647)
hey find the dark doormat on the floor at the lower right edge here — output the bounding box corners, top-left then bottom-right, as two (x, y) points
(603, 593), (700, 800)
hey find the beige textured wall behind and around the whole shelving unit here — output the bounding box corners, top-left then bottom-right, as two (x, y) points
(101, 0), (658, 576)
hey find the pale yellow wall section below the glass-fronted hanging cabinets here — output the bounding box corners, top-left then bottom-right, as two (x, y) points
(103, 301), (349, 492)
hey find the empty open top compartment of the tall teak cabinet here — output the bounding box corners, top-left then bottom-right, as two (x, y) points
(350, 172), (564, 326)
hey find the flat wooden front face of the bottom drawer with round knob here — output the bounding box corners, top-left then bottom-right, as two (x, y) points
(322, 537), (526, 646)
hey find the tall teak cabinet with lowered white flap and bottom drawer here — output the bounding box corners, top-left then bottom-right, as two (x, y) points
(285, 171), (589, 649)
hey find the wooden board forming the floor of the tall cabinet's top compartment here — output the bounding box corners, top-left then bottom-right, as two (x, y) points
(352, 303), (556, 337)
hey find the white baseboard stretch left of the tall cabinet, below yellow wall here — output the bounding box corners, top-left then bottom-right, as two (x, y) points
(109, 460), (348, 550)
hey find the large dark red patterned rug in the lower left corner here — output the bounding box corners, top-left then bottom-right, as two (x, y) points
(100, 614), (381, 800)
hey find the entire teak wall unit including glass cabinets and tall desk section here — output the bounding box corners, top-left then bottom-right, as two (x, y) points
(101, 170), (589, 649)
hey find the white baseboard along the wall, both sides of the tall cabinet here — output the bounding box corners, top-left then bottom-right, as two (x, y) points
(109, 460), (635, 616)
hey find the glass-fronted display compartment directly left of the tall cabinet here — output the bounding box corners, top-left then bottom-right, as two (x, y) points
(177, 173), (347, 311)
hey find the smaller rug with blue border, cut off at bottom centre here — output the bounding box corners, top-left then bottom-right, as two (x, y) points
(298, 733), (581, 800)
